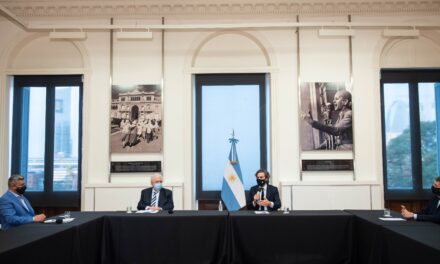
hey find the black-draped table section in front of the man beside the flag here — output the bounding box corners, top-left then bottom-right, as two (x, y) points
(229, 211), (353, 264)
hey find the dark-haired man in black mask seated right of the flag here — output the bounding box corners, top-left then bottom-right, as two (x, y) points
(246, 169), (281, 211)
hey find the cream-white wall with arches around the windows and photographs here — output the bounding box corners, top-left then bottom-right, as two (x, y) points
(0, 12), (440, 210)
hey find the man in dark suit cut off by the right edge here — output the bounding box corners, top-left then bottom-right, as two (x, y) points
(401, 177), (440, 224)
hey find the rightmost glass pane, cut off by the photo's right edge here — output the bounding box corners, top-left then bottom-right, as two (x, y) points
(419, 83), (440, 189)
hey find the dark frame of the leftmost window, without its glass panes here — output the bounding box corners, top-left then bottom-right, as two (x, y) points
(11, 75), (83, 207)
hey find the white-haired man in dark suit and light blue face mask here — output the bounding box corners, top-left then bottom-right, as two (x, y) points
(137, 174), (174, 210)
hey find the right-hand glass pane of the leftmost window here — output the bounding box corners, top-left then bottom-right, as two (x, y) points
(53, 87), (79, 191)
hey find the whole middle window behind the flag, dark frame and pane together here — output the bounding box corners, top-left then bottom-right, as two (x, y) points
(195, 74), (269, 200)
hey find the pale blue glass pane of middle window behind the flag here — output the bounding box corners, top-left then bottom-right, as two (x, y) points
(201, 85), (260, 191)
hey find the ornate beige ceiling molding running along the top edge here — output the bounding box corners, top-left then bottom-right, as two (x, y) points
(0, 0), (440, 18)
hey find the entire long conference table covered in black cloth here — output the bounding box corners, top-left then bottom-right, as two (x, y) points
(0, 210), (440, 264)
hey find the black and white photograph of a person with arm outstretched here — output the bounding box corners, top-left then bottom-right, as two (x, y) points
(300, 82), (353, 151)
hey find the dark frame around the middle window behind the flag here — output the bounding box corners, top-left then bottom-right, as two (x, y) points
(194, 73), (269, 200)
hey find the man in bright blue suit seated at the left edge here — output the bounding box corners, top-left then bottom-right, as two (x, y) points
(0, 175), (46, 230)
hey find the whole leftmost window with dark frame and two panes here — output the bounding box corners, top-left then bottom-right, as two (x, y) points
(11, 75), (82, 207)
